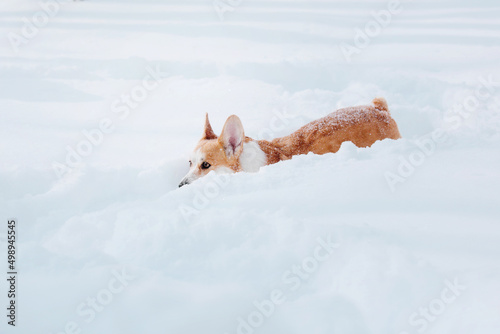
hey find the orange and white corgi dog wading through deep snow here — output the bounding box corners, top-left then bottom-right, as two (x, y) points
(179, 98), (401, 187)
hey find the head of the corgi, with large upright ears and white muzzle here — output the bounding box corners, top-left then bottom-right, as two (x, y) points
(179, 114), (245, 187)
